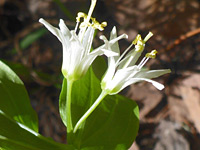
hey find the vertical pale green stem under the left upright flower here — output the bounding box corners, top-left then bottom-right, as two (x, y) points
(66, 80), (74, 143)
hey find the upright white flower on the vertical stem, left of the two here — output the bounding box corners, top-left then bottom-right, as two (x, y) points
(39, 0), (124, 81)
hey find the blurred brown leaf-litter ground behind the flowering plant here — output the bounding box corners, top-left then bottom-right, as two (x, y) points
(0, 0), (200, 150)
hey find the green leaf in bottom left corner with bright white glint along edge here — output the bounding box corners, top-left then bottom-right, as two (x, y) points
(0, 111), (74, 150)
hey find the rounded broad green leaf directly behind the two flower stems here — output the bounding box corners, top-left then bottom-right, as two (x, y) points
(60, 69), (139, 150)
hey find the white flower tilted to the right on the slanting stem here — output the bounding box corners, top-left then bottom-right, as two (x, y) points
(101, 27), (171, 95)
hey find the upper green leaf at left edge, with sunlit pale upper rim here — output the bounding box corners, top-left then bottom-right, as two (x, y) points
(0, 61), (38, 132)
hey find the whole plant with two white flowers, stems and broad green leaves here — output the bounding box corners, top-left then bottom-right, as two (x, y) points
(0, 0), (170, 150)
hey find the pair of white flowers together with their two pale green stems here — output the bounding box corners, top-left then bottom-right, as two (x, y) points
(39, 0), (170, 133)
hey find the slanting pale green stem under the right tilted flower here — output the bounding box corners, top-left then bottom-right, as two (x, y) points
(73, 91), (108, 133)
